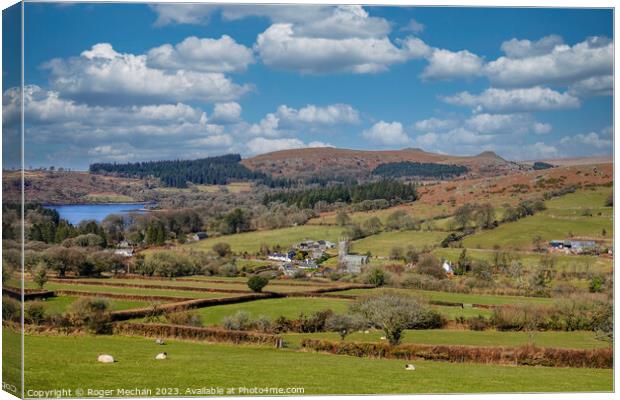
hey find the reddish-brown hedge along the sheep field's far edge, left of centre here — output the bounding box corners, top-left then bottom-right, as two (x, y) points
(113, 323), (282, 346)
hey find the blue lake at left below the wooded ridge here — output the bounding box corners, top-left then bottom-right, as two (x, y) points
(46, 203), (148, 225)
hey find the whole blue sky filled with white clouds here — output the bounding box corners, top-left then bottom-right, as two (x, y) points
(3, 3), (613, 169)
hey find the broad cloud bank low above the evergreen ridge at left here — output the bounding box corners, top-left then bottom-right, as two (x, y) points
(2, 85), (233, 166)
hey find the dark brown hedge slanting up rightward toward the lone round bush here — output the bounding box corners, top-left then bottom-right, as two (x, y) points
(110, 293), (279, 321)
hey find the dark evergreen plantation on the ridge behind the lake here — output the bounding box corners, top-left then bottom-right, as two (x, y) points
(89, 154), (265, 188)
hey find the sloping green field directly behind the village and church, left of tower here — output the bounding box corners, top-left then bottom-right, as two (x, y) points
(184, 225), (343, 253)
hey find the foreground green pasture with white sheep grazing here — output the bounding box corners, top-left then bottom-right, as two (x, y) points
(17, 330), (613, 396)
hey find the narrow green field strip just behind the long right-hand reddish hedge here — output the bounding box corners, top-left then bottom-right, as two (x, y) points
(284, 329), (609, 349)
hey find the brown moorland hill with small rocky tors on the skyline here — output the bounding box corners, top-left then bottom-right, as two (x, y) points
(241, 147), (526, 178)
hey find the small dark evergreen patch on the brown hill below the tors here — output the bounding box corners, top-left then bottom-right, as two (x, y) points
(372, 161), (468, 179)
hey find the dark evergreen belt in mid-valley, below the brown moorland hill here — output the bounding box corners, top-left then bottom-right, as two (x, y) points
(263, 179), (417, 208)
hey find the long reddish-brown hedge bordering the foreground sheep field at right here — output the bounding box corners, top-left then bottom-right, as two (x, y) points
(301, 339), (613, 368)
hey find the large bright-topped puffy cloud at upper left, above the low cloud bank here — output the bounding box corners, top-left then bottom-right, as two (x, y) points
(44, 43), (251, 104)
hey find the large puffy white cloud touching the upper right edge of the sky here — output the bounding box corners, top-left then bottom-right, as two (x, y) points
(485, 37), (614, 86)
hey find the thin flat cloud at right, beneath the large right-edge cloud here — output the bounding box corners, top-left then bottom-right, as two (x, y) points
(443, 86), (580, 112)
